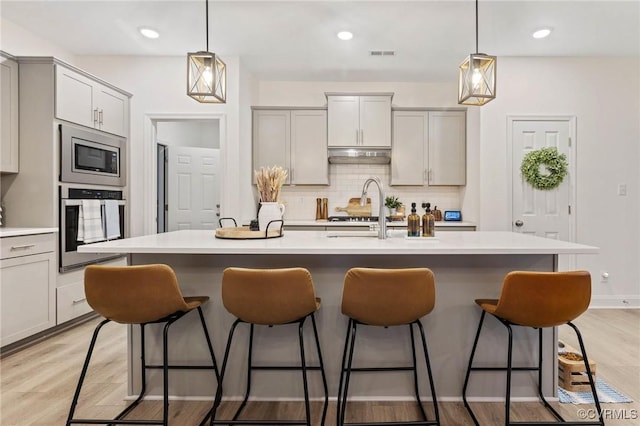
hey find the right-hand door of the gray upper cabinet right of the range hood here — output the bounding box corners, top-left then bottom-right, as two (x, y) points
(429, 111), (467, 185)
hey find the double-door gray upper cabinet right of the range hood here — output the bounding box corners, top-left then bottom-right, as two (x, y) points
(391, 108), (467, 186)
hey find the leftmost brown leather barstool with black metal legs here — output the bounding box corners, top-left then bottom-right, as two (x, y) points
(67, 265), (220, 426)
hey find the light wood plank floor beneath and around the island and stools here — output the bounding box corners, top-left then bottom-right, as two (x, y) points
(0, 310), (640, 426)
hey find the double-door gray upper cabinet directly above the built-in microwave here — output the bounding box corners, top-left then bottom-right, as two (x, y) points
(55, 65), (129, 137)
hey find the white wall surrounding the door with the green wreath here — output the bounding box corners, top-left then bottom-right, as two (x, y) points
(479, 57), (640, 306)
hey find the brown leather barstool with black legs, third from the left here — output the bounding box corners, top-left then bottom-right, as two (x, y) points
(337, 268), (440, 426)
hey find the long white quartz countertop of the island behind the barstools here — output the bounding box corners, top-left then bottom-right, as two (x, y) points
(78, 230), (599, 255)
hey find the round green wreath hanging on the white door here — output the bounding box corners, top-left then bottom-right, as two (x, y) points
(520, 147), (569, 190)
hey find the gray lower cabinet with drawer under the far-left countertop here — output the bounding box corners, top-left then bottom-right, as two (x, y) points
(0, 233), (56, 346)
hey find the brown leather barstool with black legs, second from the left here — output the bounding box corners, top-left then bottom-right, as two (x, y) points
(201, 268), (329, 426)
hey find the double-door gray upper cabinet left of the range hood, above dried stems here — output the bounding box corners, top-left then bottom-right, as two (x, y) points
(253, 107), (329, 185)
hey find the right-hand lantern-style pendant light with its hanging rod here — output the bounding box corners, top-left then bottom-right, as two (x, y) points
(458, 0), (497, 105)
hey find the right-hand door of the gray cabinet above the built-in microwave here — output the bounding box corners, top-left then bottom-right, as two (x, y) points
(94, 83), (129, 137)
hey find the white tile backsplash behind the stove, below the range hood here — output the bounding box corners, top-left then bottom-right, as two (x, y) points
(280, 164), (461, 220)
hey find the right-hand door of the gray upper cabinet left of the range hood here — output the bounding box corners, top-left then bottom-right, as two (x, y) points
(289, 110), (329, 185)
